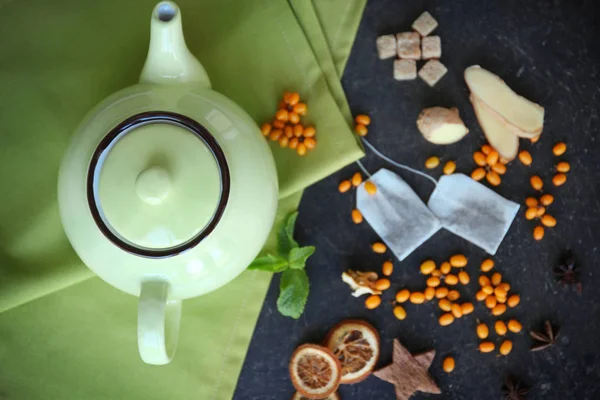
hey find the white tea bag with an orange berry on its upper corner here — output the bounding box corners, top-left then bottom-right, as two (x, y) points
(356, 169), (441, 261)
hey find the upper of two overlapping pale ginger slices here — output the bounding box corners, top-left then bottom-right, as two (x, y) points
(465, 65), (544, 138)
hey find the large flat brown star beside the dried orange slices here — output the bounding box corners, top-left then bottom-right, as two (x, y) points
(373, 339), (442, 400)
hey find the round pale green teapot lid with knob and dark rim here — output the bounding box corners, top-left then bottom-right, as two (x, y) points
(87, 112), (229, 257)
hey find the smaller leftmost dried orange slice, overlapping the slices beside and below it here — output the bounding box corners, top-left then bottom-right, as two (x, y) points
(289, 344), (342, 399)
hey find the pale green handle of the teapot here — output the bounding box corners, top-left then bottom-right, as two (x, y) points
(138, 279), (181, 365)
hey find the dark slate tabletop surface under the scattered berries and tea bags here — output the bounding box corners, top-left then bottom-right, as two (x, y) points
(234, 0), (600, 400)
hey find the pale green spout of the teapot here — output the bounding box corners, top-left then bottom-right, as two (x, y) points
(140, 1), (210, 88)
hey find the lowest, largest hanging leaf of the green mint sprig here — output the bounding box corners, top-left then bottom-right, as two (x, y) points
(277, 269), (309, 319)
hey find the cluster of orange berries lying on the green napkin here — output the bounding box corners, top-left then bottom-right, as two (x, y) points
(260, 92), (317, 156)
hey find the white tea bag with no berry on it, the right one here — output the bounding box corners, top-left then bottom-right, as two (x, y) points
(428, 174), (520, 255)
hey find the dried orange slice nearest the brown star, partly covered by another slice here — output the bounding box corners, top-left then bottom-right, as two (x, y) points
(325, 320), (379, 384)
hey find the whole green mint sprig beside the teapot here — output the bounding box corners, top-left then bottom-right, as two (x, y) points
(248, 212), (315, 319)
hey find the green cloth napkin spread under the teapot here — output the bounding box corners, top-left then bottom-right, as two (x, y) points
(0, 0), (365, 400)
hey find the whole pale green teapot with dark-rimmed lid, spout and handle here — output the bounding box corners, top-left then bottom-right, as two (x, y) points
(58, 1), (278, 364)
